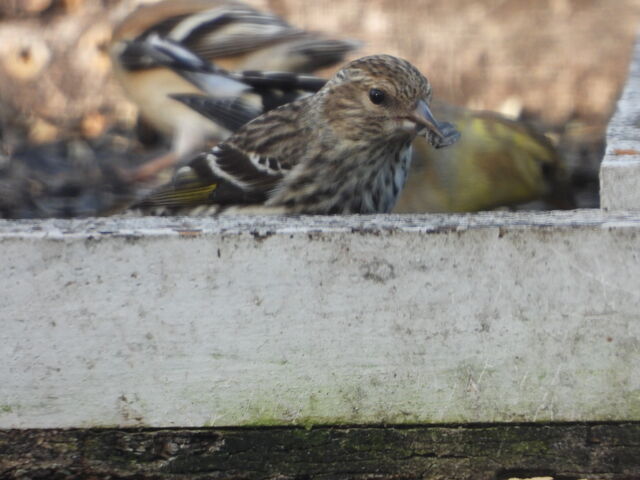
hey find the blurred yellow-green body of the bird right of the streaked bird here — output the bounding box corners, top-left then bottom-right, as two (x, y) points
(394, 103), (575, 213)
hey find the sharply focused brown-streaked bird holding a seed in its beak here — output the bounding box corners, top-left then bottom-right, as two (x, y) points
(139, 55), (459, 214)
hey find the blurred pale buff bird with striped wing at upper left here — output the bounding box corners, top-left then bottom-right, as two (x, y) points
(110, 0), (357, 180)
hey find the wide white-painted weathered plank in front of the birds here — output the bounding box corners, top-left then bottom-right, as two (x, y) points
(0, 211), (640, 428)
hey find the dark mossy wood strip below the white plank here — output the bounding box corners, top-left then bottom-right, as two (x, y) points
(0, 424), (640, 480)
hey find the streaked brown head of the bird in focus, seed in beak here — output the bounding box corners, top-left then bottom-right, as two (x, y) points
(323, 55), (460, 148)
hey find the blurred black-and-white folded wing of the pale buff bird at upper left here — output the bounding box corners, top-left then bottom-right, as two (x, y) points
(115, 0), (359, 73)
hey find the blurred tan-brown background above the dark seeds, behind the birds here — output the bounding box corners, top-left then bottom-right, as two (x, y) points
(0, 0), (640, 206)
